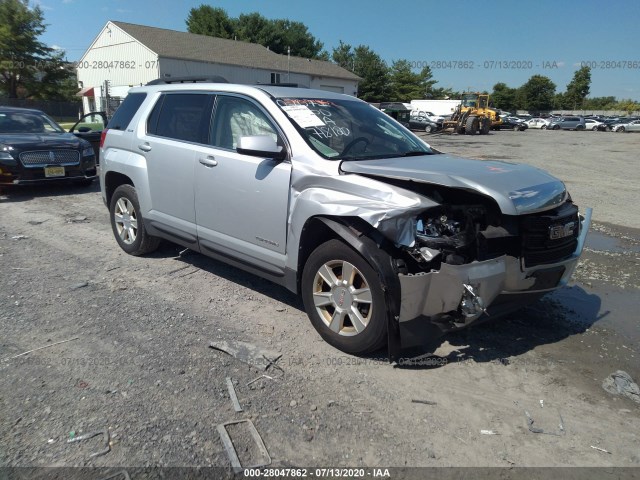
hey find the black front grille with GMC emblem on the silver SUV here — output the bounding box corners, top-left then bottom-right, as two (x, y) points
(520, 203), (580, 267)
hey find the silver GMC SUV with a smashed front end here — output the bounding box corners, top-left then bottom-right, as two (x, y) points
(100, 79), (591, 358)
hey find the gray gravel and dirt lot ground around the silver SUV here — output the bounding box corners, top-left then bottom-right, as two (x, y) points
(0, 131), (640, 471)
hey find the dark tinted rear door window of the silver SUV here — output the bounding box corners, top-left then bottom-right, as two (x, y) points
(147, 93), (214, 143)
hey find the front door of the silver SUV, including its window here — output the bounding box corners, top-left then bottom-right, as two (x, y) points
(190, 94), (291, 276)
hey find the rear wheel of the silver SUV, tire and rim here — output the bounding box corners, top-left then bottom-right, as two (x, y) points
(109, 185), (160, 255)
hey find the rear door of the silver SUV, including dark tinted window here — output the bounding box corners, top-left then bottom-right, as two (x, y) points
(137, 91), (215, 248)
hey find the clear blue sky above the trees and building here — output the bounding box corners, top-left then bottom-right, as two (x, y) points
(31, 0), (640, 101)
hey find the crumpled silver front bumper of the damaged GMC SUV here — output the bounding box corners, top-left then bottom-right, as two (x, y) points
(398, 208), (592, 348)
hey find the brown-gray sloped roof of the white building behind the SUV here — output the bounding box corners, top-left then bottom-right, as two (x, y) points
(111, 21), (361, 81)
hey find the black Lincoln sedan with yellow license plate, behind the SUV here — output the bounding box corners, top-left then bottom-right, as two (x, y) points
(0, 107), (96, 185)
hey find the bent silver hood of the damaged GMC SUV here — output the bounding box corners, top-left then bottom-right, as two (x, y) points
(340, 154), (567, 215)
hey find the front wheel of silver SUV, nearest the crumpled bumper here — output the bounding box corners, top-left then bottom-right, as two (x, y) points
(301, 240), (387, 355)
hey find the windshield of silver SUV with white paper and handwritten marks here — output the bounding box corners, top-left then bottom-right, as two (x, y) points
(274, 98), (433, 160)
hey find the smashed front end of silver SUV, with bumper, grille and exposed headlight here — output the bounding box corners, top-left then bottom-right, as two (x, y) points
(390, 190), (591, 353)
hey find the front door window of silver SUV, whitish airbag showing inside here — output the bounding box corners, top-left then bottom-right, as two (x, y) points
(211, 96), (278, 150)
